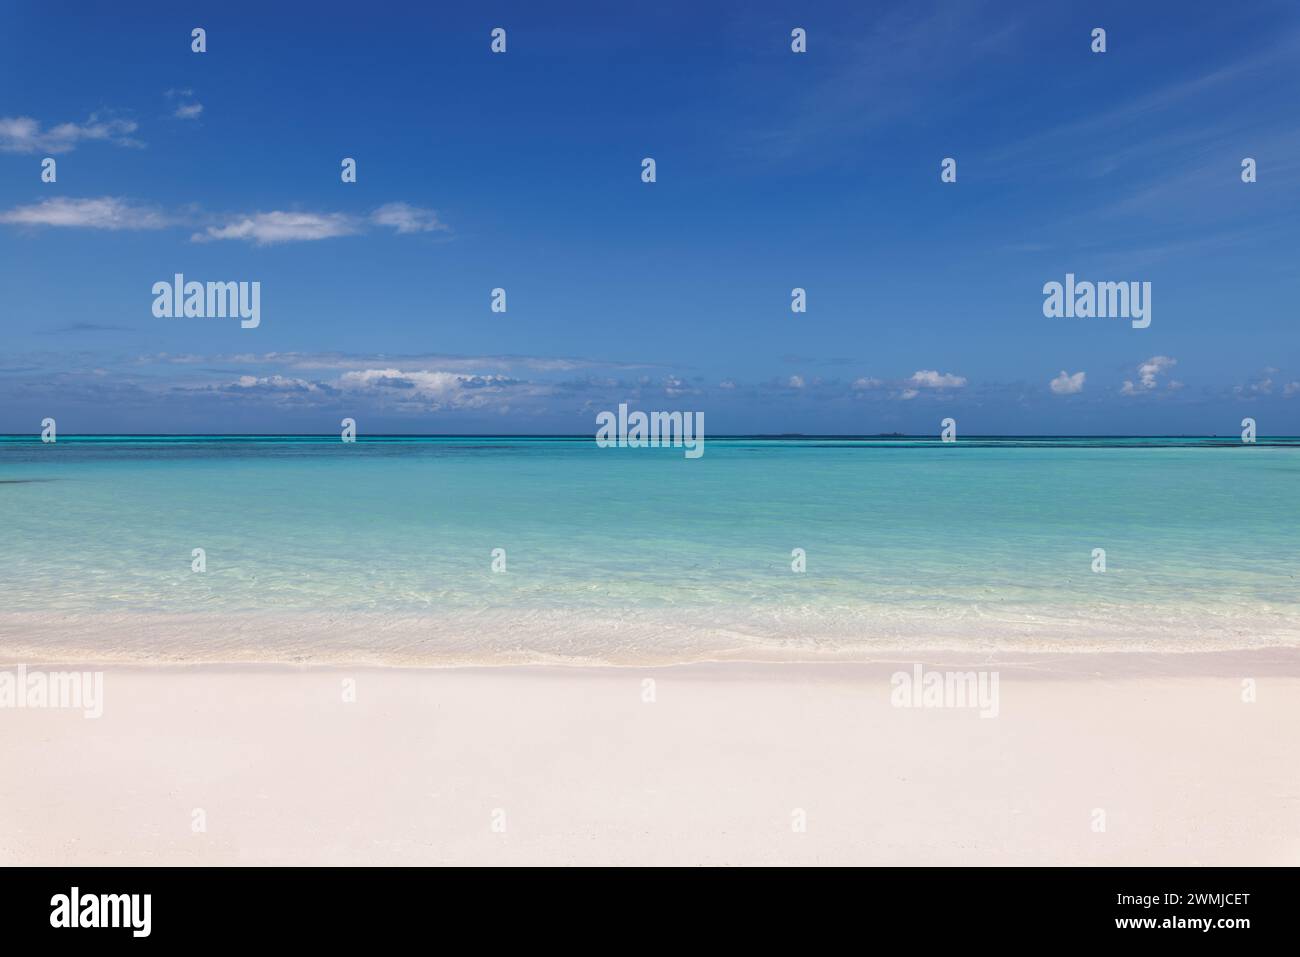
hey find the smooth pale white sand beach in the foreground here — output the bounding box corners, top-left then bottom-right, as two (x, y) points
(0, 651), (1300, 865)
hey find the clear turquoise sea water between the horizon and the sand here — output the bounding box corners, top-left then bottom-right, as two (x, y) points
(0, 436), (1300, 664)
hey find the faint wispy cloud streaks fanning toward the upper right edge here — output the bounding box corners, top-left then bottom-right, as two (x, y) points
(979, 23), (1300, 257)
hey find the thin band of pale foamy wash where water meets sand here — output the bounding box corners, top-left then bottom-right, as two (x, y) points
(0, 607), (1300, 666)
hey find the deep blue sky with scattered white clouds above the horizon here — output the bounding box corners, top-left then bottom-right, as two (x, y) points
(0, 0), (1300, 434)
